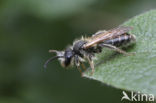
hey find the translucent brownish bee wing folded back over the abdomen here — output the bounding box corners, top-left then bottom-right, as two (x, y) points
(83, 27), (132, 49)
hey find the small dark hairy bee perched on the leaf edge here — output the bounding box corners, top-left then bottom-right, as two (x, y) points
(44, 27), (136, 75)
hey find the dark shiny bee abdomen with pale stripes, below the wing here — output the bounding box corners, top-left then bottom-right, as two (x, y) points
(103, 33), (136, 47)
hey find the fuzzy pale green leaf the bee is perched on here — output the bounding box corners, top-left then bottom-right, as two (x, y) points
(84, 10), (156, 96)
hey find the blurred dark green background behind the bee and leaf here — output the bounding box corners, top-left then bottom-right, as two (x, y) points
(0, 0), (156, 103)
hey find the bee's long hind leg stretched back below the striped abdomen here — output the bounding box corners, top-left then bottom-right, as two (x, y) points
(100, 44), (135, 56)
